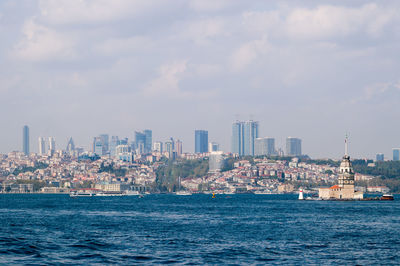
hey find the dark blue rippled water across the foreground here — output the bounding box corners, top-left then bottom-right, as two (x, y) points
(0, 195), (400, 265)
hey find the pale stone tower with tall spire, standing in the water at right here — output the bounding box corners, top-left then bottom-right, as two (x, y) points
(318, 136), (364, 200)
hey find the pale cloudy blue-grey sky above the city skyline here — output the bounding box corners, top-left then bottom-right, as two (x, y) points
(0, 0), (400, 159)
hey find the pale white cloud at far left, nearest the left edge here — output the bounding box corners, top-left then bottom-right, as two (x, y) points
(13, 20), (76, 61)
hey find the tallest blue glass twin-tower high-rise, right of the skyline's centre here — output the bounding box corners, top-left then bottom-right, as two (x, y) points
(232, 120), (259, 156)
